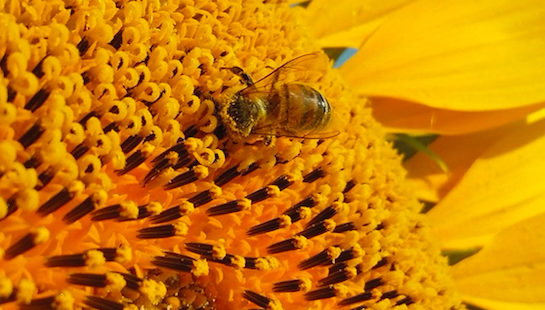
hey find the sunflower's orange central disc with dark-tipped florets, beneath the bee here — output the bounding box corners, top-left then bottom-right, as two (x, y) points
(0, 0), (461, 310)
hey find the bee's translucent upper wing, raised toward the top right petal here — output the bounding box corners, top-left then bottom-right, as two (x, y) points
(240, 52), (327, 95)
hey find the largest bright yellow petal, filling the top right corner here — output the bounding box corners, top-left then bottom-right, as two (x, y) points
(341, 0), (545, 111)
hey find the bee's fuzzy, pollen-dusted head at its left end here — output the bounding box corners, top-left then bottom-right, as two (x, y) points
(221, 95), (260, 137)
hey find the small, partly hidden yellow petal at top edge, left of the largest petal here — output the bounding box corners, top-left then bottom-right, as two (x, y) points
(307, 0), (412, 47)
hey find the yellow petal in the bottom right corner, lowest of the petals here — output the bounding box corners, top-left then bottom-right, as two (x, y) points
(452, 213), (545, 309)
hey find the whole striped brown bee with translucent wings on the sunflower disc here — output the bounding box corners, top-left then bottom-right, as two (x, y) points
(219, 53), (337, 144)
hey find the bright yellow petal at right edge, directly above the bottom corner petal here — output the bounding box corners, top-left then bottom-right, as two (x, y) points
(428, 121), (545, 248)
